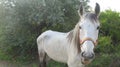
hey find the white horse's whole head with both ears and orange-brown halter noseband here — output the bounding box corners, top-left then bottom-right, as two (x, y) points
(78, 3), (100, 64)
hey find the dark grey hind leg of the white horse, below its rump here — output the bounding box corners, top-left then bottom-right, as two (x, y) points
(39, 51), (46, 67)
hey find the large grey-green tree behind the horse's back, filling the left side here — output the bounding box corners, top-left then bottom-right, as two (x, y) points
(0, 0), (88, 60)
